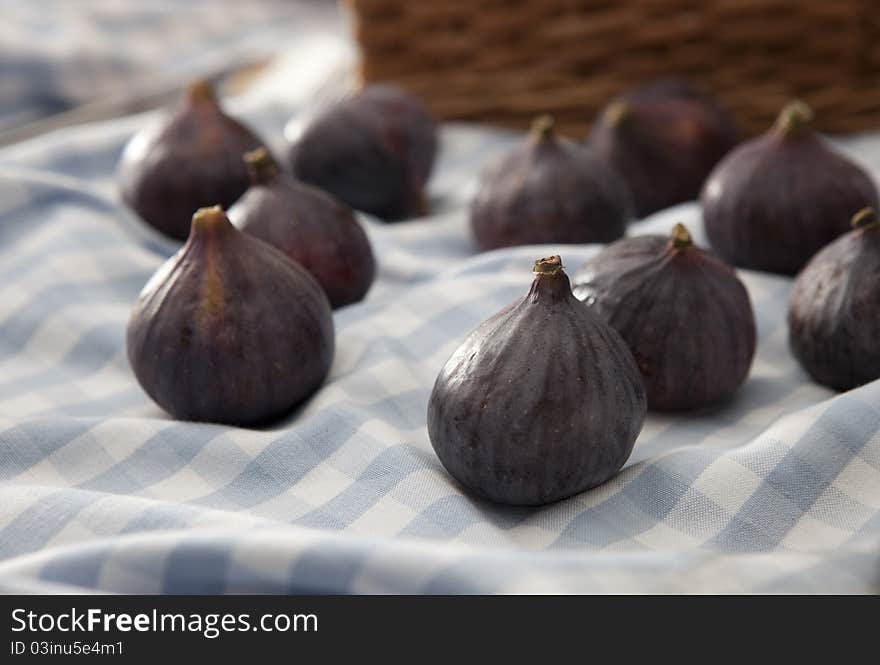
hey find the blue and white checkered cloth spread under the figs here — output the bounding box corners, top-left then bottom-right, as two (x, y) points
(0, 11), (880, 593)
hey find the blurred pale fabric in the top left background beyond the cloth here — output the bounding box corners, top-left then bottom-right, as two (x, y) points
(0, 0), (337, 131)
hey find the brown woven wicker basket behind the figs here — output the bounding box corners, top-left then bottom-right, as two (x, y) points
(347, 0), (880, 136)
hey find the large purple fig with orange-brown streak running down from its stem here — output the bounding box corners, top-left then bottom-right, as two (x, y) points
(126, 207), (335, 425)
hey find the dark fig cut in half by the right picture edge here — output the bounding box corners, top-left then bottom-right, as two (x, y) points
(788, 208), (880, 390)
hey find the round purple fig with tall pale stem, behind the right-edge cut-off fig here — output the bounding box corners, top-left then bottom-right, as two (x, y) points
(701, 101), (877, 275)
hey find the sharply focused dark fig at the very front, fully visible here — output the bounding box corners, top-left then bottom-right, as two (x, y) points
(428, 256), (645, 505)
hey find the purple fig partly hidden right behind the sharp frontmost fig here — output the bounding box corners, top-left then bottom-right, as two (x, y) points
(573, 224), (755, 411)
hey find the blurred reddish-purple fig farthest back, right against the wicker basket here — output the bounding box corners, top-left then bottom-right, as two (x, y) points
(588, 80), (739, 217)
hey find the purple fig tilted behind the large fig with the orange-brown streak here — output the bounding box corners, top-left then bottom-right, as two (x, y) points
(229, 148), (376, 308)
